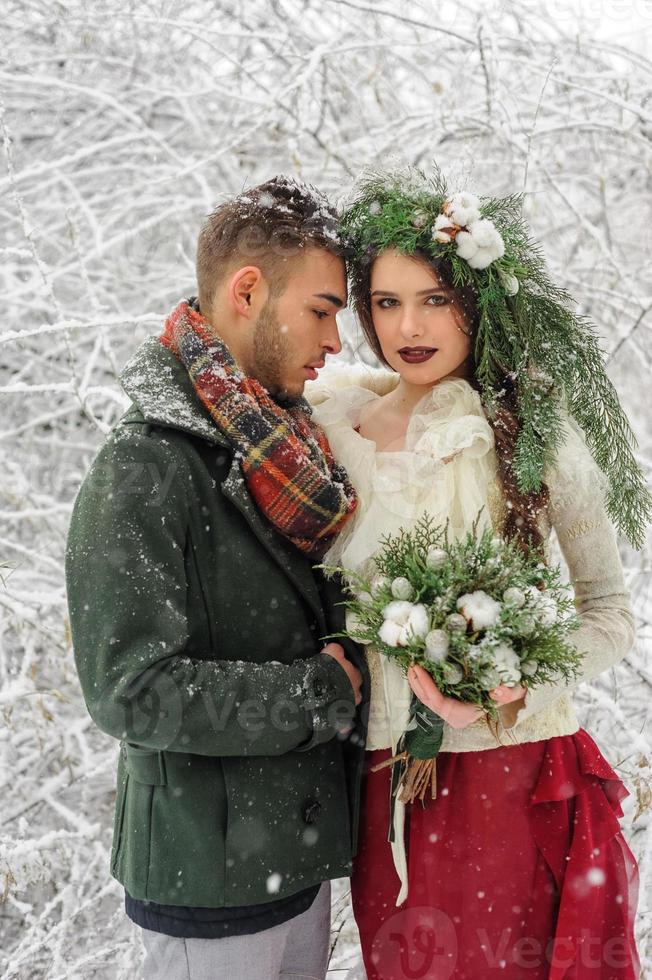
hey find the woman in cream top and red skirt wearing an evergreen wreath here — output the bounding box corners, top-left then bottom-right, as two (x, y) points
(306, 173), (650, 980)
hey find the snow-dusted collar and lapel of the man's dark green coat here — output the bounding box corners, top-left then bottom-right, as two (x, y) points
(120, 337), (326, 633)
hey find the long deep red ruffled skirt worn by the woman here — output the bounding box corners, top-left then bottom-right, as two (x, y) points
(351, 729), (639, 980)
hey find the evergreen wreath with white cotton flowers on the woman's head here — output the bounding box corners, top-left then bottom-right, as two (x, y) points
(340, 164), (652, 548)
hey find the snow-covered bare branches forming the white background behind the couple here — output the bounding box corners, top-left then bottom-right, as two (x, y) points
(0, 0), (652, 980)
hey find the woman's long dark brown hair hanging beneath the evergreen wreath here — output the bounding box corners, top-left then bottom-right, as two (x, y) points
(351, 252), (549, 550)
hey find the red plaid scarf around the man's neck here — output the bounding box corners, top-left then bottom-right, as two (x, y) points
(159, 299), (357, 557)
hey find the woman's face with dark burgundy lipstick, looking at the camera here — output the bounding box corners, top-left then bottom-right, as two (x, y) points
(371, 249), (471, 385)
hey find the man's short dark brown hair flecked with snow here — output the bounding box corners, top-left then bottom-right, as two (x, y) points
(196, 175), (342, 315)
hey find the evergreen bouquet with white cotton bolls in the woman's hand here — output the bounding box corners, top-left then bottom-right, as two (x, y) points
(320, 514), (582, 802)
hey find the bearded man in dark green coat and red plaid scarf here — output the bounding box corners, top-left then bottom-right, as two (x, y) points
(66, 177), (368, 980)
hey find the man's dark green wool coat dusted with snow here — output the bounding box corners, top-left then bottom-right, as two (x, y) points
(66, 337), (369, 907)
